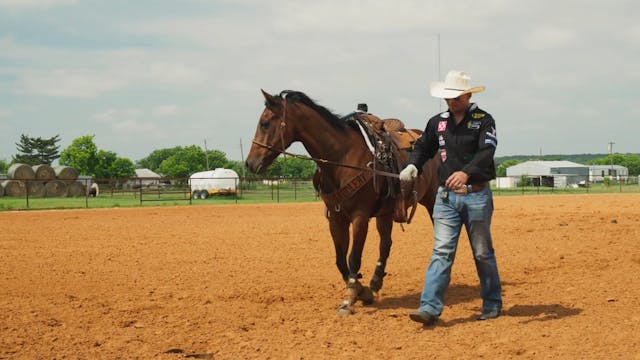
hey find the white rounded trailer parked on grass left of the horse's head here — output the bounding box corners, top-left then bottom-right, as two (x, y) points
(189, 168), (239, 199)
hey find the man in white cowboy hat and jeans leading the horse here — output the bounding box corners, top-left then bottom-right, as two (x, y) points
(400, 71), (502, 326)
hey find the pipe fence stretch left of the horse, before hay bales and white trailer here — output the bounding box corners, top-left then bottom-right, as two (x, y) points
(0, 177), (318, 211)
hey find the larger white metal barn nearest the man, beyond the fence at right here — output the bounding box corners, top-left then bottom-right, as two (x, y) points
(507, 160), (589, 188)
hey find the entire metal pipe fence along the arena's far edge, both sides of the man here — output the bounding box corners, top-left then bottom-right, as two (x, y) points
(0, 175), (640, 211)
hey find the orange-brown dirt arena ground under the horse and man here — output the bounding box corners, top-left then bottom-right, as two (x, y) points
(0, 194), (640, 359)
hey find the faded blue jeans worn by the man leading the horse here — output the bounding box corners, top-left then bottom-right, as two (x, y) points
(419, 186), (502, 316)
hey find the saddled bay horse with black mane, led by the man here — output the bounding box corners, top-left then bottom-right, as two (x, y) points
(245, 90), (439, 315)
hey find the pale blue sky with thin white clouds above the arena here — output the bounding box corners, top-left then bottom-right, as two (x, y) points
(0, 0), (640, 161)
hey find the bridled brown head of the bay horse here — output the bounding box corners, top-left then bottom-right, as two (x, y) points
(245, 90), (293, 174)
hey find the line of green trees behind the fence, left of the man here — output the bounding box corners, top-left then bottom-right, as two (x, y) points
(0, 134), (316, 179)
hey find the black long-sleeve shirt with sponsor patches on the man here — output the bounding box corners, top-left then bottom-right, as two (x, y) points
(409, 103), (498, 184)
